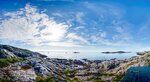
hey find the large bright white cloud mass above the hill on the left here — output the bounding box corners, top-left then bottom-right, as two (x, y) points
(0, 4), (87, 46)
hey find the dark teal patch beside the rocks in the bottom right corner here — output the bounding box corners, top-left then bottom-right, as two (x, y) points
(122, 66), (150, 82)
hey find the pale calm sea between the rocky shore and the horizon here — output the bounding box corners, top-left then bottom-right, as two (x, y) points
(39, 51), (137, 60)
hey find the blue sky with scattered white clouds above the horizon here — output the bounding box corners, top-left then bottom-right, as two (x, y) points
(0, 0), (150, 51)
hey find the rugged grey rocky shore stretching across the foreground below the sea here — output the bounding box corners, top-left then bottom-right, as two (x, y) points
(0, 45), (147, 82)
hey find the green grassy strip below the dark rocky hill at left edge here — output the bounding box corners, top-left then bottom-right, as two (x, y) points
(0, 57), (25, 68)
